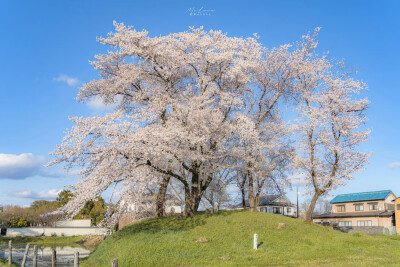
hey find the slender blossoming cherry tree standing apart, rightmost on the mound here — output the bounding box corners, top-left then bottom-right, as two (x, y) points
(295, 29), (370, 222)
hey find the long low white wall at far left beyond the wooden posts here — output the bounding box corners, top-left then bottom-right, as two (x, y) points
(6, 227), (107, 237)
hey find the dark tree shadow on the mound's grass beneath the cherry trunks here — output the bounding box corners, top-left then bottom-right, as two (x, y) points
(117, 211), (240, 236)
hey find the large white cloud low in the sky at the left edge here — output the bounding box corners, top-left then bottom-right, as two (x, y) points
(0, 153), (46, 179)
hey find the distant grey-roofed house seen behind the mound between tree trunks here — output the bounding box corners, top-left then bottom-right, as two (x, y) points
(237, 195), (297, 217)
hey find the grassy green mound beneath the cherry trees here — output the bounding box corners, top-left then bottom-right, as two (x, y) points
(81, 211), (400, 267)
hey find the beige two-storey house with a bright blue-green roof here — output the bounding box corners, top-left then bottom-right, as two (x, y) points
(313, 190), (396, 237)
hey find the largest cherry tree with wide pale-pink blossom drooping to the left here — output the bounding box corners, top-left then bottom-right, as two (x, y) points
(52, 24), (268, 220)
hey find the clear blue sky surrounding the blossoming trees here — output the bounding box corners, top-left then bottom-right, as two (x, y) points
(0, 0), (400, 205)
